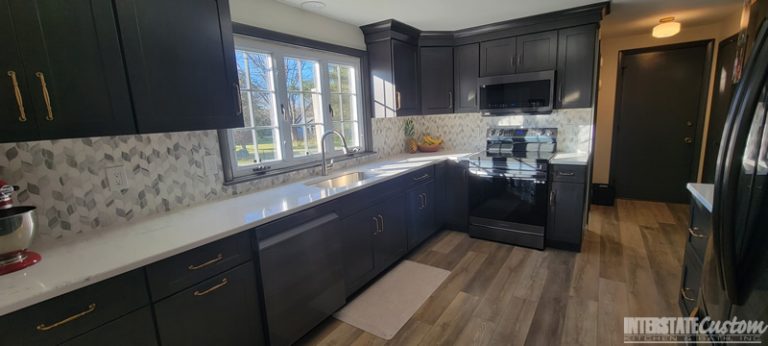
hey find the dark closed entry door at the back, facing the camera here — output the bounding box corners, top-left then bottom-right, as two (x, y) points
(611, 41), (712, 202)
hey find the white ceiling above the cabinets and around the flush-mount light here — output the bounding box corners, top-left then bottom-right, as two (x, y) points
(272, 0), (743, 36)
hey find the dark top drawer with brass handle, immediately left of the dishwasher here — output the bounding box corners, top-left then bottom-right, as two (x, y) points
(147, 232), (251, 301)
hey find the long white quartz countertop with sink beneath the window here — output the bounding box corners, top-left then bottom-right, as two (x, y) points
(0, 152), (469, 316)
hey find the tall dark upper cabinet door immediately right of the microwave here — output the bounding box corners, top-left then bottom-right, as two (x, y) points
(555, 25), (597, 108)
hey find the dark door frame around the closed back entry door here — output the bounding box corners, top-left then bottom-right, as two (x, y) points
(608, 39), (715, 193)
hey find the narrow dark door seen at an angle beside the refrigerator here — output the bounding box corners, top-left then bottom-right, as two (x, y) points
(701, 35), (739, 184)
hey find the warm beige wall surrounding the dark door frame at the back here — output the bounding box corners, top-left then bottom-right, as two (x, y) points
(592, 13), (741, 183)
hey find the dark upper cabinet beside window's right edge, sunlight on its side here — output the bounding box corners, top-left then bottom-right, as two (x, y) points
(361, 20), (421, 118)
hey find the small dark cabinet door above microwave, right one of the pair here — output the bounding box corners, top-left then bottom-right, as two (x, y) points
(517, 31), (557, 73)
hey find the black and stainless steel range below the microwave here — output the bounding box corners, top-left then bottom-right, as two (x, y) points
(463, 127), (557, 249)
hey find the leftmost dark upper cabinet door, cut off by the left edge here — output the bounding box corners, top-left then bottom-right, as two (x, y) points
(0, 0), (39, 142)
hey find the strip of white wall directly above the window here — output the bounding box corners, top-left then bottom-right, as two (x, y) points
(230, 0), (365, 50)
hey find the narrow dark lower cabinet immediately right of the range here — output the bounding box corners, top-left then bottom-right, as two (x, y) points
(546, 165), (587, 251)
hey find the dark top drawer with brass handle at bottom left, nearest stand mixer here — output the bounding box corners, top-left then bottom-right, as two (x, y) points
(0, 270), (149, 346)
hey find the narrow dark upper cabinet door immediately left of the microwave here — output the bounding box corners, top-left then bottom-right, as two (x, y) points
(453, 43), (480, 112)
